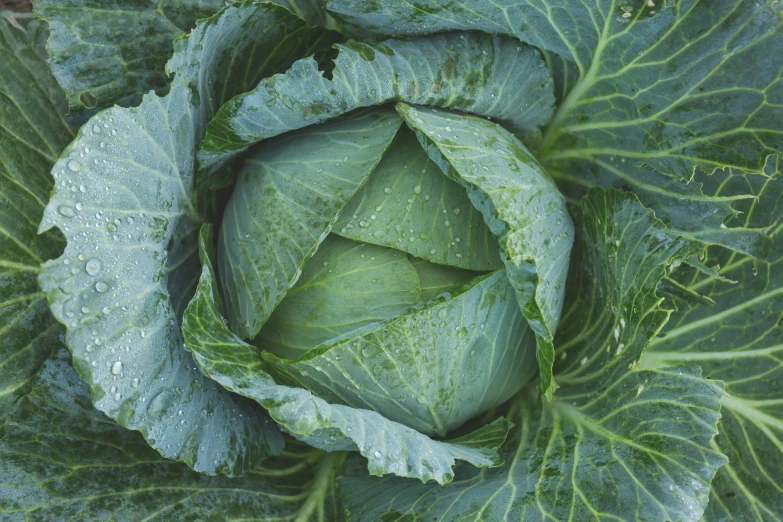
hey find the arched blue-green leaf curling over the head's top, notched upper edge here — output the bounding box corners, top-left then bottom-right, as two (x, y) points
(198, 33), (554, 186)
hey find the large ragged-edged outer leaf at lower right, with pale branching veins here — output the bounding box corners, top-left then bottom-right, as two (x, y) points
(341, 189), (726, 522)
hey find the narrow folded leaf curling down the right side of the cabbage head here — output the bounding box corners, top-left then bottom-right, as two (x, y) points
(397, 104), (574, 398)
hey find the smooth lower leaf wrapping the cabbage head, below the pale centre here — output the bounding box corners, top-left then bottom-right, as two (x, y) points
(262, 260), (536, 436)
